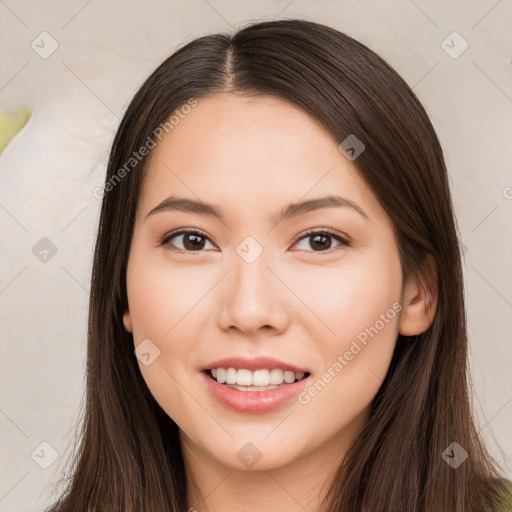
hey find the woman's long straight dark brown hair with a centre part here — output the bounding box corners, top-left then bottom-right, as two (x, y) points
(46, 19), (510, 512)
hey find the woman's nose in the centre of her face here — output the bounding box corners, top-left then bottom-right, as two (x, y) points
(219, 251), (290, 334)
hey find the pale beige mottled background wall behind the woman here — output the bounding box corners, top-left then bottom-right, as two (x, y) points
(0, 0), (512, 512)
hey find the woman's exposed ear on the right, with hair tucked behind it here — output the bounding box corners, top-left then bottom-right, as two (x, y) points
(398, 255), (438, 336)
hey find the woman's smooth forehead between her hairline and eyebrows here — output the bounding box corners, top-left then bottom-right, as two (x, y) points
(139, 94), (372, 221)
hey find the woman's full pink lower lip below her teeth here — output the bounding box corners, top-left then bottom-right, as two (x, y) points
(201, 372), (311, 414)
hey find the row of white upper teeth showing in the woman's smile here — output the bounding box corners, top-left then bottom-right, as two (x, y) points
(211, 368), (304, 391)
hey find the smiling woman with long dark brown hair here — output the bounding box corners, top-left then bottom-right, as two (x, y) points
(46, 20), (510, 512)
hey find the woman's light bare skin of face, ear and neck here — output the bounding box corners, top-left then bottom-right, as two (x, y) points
(124, 94), (435, 512)
